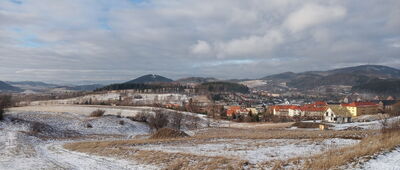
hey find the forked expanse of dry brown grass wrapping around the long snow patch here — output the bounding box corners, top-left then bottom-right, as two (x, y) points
(64, 128), (379, 169)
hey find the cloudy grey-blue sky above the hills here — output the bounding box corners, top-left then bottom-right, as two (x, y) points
(0, 0), (400, 83)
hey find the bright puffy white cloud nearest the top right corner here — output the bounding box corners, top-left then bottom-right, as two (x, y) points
(284, 4), (346, 32)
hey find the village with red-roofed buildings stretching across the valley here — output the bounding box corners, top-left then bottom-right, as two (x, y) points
(21, 86), (400, 126)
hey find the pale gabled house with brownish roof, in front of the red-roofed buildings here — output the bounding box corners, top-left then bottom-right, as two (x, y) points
(323, 105), (352, 123)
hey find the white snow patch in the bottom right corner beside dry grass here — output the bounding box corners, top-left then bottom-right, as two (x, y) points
(361, 147), (400, 170)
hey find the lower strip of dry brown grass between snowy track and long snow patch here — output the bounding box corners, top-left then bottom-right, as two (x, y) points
(64, 143), (246, 170)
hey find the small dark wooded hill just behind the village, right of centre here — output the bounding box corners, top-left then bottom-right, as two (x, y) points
(196, 82), (250, 93)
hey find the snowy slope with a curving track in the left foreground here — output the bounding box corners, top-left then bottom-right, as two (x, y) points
(0, 112), (158, 170)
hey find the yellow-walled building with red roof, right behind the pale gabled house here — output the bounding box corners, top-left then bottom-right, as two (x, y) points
(341, 102), (378, 117)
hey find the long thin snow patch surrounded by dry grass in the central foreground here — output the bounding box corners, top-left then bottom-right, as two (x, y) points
(133, 139), (358, 164)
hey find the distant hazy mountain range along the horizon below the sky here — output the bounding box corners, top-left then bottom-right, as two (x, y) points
(0, 65), (400, 93)
